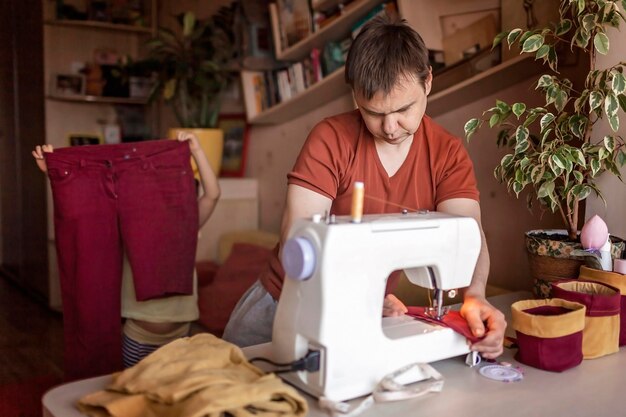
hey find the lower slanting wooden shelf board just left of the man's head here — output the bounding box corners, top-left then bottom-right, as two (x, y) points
(248, 67), (350, 124)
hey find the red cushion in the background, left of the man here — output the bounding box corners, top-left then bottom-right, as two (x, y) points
(198, 243), (272, 337)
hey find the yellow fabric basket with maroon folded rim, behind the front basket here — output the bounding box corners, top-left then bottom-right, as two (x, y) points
(552, 280), (621, 359)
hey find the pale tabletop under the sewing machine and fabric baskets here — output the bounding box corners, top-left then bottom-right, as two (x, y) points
(42, 293), (626, 417)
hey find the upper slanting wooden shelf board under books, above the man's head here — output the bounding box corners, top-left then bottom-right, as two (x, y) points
(271, 0), (383, 61)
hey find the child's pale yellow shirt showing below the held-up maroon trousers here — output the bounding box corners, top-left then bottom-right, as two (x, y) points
(121, 256), (200, 323)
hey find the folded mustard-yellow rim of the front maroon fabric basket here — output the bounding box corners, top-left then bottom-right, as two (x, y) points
(511, 298), (587, 339)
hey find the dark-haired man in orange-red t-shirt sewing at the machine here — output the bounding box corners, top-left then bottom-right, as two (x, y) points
(223, 16), (506, 359)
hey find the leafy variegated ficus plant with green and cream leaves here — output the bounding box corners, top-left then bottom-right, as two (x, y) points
(465, 0), (626, 240)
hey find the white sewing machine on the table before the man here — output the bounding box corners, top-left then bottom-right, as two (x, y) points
(271, 212), (481, 401)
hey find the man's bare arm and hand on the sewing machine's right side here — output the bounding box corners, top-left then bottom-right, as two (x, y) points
(437, 198), (506, 359)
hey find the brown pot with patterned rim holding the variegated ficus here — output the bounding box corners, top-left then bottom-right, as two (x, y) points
(526, 229), (624, 298)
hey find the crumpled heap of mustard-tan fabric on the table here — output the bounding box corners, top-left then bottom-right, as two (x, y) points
(78, 333), (307, 417)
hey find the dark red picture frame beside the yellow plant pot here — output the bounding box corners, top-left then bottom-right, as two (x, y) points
(217, 113), (250, 177)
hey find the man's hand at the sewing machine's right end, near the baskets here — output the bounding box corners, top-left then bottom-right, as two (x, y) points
(461, 294), (506, 359)
